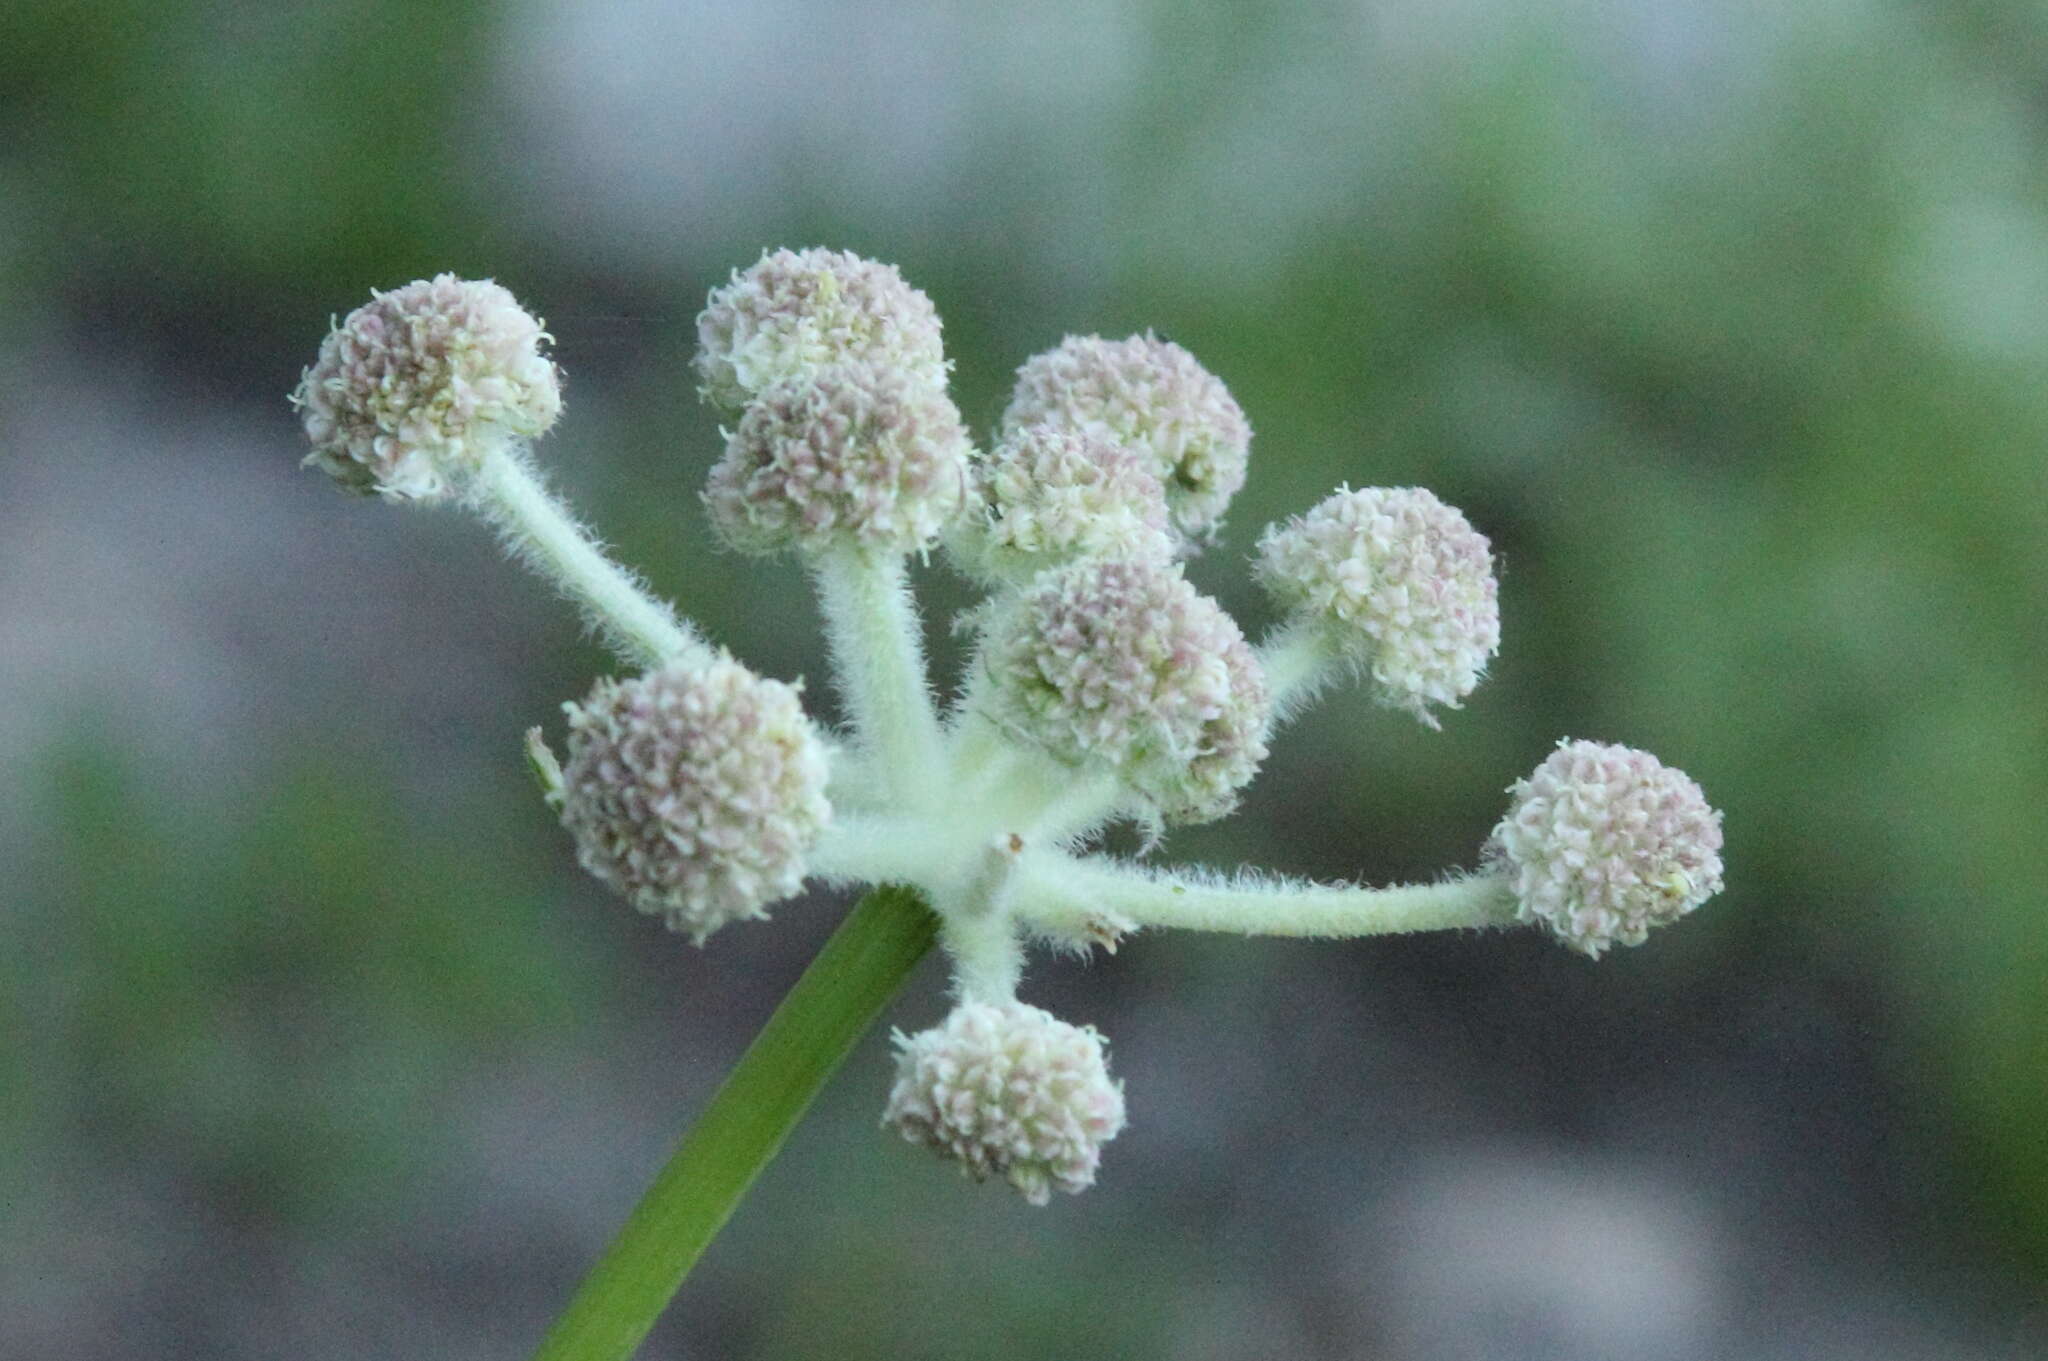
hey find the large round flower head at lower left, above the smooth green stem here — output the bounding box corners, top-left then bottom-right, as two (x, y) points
(561, 655), (831, 943)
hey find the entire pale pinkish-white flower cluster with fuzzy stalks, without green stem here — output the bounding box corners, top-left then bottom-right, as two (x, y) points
(293, 250), (1722, 1203)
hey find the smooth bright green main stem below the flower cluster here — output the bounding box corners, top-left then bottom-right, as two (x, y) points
(535, 884), (938, 1361)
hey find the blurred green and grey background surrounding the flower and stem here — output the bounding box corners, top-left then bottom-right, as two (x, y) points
(0, 0), (2048, 1361)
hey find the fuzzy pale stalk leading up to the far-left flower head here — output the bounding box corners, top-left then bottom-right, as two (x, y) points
(469, 446), (711, 667)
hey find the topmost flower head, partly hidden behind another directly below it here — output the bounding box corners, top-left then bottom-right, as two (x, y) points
(696, 248), (946, 411)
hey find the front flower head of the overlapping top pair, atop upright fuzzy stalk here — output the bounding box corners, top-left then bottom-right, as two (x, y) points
(705, 364), (973, 553)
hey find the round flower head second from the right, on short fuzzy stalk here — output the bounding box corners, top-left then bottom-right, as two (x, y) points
(1255, 487), (1501, 727)
